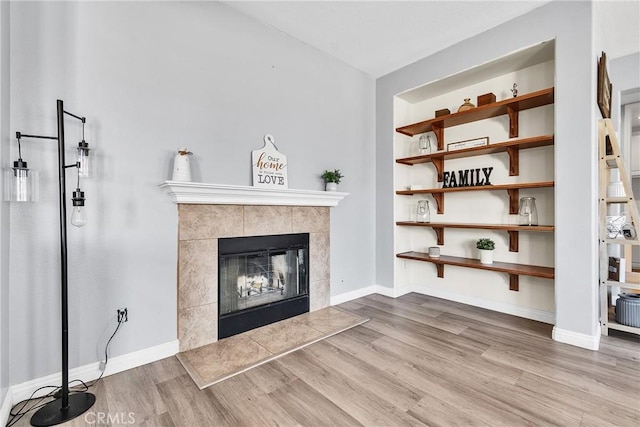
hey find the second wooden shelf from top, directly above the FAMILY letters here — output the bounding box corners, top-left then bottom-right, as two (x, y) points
(396, 135), (554, 182)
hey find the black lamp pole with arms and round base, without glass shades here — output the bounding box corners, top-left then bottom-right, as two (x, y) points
(18, 99), (96, 426)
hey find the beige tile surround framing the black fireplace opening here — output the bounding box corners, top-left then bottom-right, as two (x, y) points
(178, 203), (330, 351)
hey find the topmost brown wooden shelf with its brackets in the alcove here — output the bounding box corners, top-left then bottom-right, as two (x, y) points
(396, 87), (554, 150)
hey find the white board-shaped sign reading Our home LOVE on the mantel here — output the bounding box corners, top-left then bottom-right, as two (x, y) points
(251, 135), (289, 188)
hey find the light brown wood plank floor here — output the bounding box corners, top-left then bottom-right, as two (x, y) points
(10, 294), (640, 427)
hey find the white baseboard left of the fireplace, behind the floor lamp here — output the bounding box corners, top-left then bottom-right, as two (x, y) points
(10, 340), (179, 406)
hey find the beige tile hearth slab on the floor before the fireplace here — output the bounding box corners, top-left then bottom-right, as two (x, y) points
(177, 307), (369, 389)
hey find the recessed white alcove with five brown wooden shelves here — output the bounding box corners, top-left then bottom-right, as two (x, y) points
(392, 40), (558, 322)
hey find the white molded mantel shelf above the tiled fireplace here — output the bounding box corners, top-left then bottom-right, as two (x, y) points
(160, 181), (349, 206)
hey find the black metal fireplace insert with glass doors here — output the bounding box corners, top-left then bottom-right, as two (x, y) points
(218, 233), (309, 339)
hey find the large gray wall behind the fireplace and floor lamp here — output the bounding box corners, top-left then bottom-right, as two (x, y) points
(8, 2), (375, 384)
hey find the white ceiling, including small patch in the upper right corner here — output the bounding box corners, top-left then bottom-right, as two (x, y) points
(224, 0), (640, 78)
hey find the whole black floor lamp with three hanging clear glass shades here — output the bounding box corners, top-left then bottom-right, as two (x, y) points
(8, 100), (96, 426)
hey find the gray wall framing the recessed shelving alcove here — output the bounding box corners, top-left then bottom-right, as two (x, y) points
(376, 2), (598, 336)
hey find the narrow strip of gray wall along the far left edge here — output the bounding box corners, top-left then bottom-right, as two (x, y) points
(0, 2), (10, 404)
